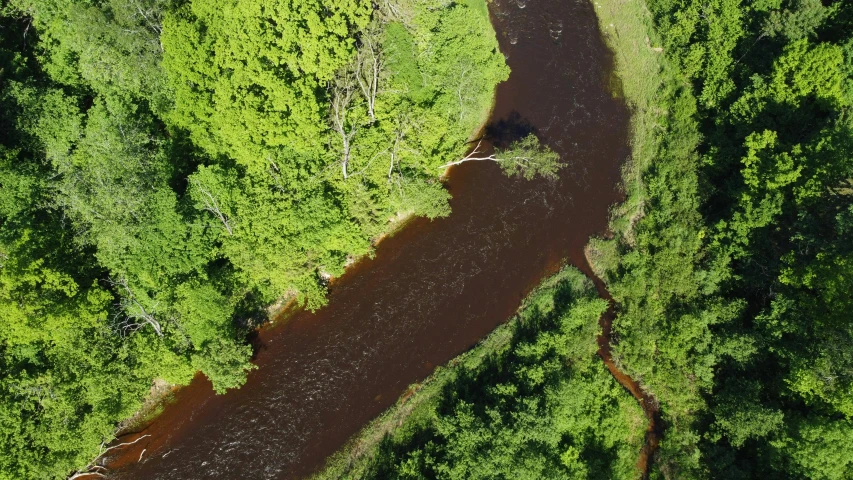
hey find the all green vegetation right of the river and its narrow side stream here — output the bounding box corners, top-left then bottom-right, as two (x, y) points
(588, 0), (853, 479)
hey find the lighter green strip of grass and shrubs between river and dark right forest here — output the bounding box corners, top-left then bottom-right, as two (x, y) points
(587, 0), (703, 476)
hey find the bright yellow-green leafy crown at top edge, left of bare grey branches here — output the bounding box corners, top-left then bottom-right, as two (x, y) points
(163, 0), (370, 168)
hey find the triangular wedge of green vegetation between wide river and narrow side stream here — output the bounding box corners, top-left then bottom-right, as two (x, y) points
(314, 267), (647, 480)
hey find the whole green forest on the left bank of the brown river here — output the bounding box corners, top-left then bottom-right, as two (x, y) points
(0, 0), (508, 478)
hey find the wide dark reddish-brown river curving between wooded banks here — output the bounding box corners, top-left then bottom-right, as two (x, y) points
(108, 0), (652, 479)
